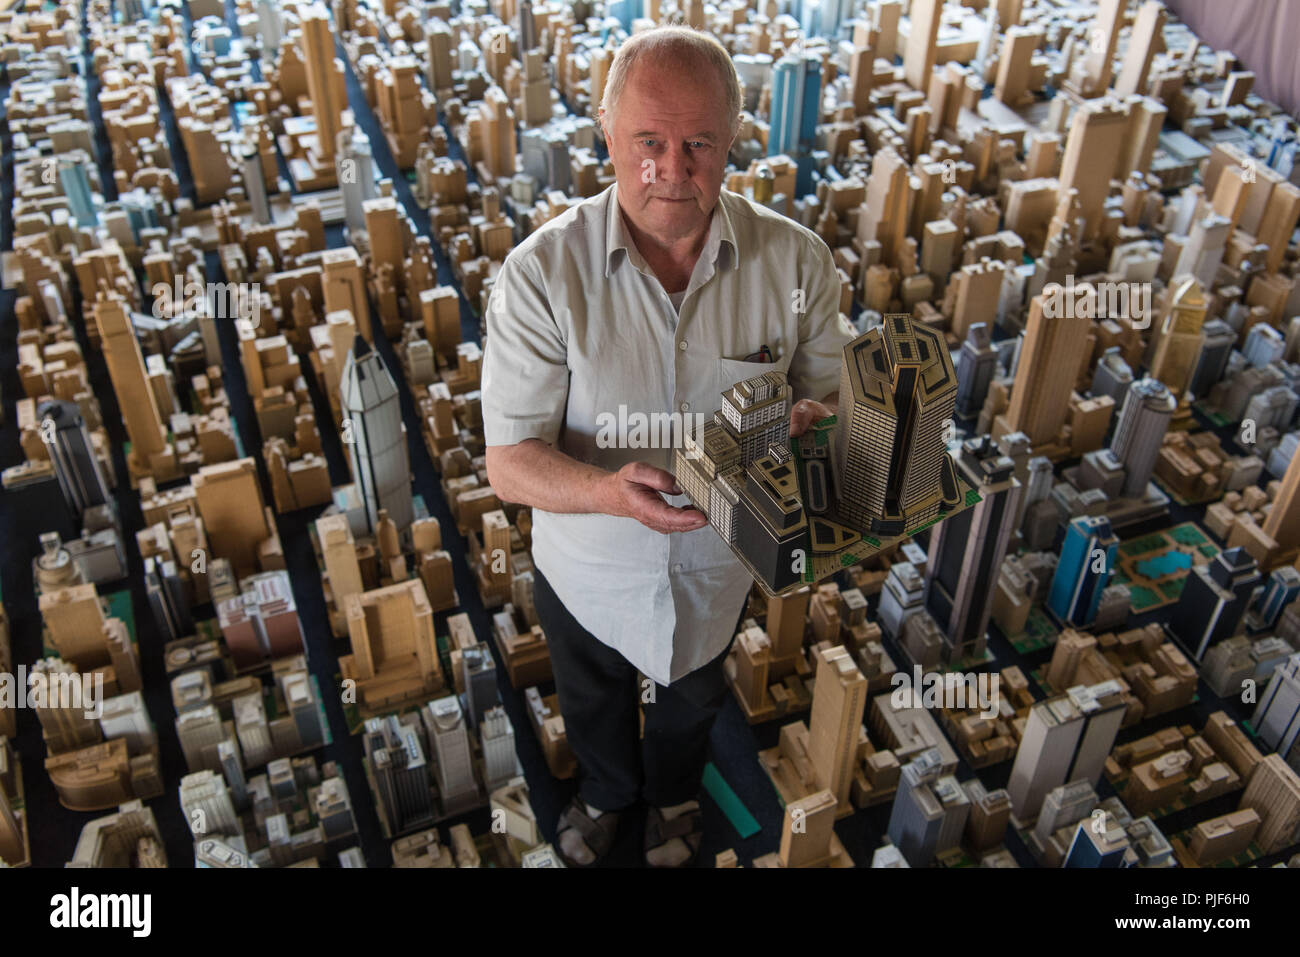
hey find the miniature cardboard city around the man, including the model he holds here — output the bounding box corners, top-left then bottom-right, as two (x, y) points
(0, 0), (1300, 873)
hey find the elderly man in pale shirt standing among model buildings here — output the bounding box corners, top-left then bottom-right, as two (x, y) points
(482, 26), (853, 867)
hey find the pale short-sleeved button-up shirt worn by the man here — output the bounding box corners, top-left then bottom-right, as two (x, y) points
(482, 180), (855, 684)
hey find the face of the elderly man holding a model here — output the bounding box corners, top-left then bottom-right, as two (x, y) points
(601, 55), (735, 243)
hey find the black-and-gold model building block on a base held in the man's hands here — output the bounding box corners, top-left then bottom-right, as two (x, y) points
(673, 313), (979, 594)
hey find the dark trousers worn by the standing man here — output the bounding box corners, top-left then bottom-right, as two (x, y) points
(533, 568), (735, 811)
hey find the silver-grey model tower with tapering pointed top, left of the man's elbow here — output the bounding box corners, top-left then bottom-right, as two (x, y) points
(338, 335), (415, 532)
